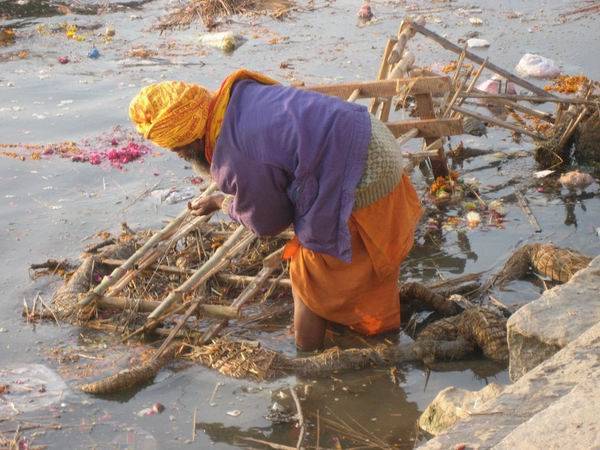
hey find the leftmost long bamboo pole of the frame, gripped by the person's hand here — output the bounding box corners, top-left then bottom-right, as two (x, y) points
(78, 183), (217, 307)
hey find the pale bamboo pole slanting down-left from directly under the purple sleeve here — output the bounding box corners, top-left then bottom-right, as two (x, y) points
(148, 229), (255, 320)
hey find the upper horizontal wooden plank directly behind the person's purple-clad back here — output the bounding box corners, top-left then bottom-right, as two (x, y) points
(300, 77), (450, 100)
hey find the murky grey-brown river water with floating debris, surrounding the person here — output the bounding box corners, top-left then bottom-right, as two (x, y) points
(0, 0), (600, 449)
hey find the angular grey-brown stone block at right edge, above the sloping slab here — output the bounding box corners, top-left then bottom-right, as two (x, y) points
(507, 256), (600, 381)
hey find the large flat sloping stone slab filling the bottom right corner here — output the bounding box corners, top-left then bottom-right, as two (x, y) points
(421, 323), (600, 450)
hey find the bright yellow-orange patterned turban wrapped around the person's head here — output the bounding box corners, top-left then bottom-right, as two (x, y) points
(129, 81), (211, 148)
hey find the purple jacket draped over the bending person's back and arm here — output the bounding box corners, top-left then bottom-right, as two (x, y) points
(211, 80), (371, 262)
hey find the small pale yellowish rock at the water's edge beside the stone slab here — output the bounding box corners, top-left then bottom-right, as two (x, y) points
(419, 383), (503, 436)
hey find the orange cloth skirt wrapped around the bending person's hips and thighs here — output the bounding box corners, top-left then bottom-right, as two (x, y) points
(286, 175), (421, 335)
